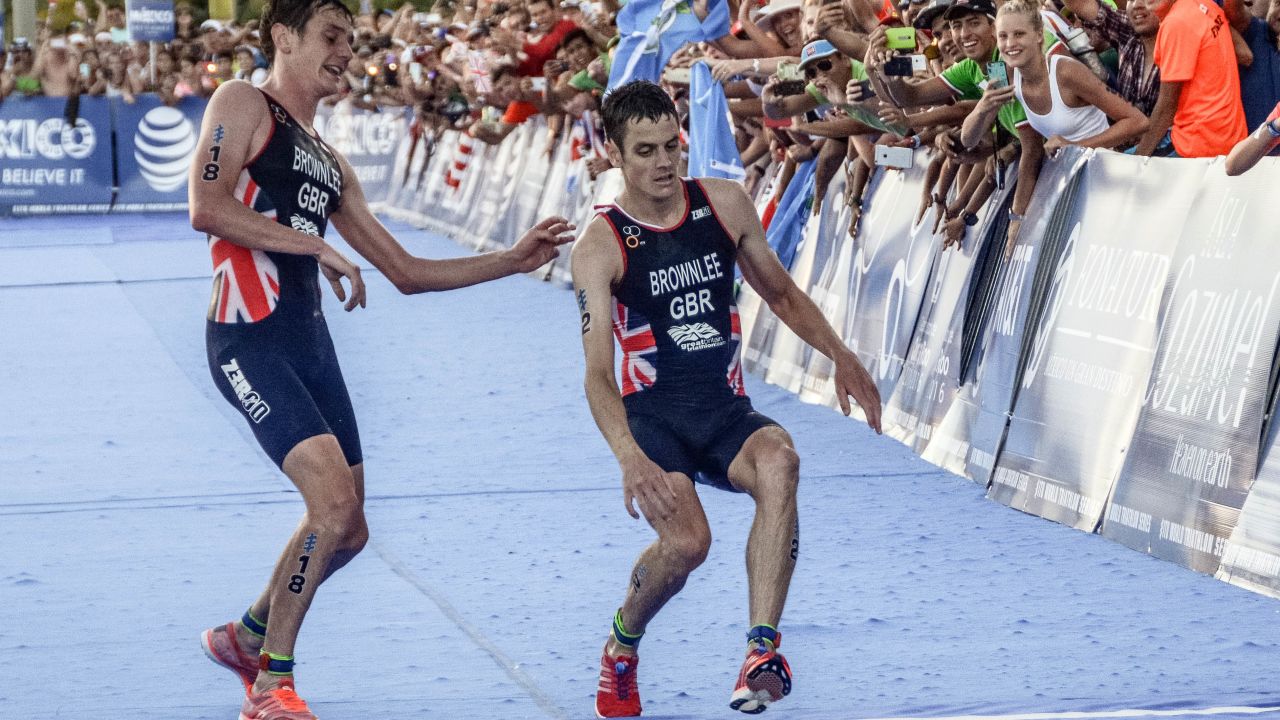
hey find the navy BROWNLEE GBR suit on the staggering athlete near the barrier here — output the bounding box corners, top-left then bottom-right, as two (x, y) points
(600, 179), (777, 489)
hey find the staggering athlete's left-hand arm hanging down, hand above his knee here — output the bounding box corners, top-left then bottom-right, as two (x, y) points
(571, 219), (680, 523)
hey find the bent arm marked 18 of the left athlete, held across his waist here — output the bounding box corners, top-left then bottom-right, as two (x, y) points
(187, 81), (365, 310)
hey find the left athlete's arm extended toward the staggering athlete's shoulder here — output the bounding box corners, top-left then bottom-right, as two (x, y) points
(332, 152), (573, 295)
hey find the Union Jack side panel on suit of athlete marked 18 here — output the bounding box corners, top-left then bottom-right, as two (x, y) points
(209, 169), (280, 323)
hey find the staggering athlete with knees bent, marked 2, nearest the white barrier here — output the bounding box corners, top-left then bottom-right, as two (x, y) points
(572, 81), (881, 717)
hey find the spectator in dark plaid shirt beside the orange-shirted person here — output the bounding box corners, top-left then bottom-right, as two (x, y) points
(1064, 0), (1160, 115)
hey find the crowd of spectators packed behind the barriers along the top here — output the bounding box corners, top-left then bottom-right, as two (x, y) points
(0, 0), (1280, 243)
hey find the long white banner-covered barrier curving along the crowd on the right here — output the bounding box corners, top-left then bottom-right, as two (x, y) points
(373, 120), (1280, 597)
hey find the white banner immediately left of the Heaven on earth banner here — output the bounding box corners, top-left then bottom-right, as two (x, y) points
(987, 152), (1203, 532)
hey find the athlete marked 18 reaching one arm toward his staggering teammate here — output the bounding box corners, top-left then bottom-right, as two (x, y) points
(189, 0), (572, 720)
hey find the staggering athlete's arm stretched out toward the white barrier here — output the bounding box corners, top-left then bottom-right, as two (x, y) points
(703, 179), (881, 433)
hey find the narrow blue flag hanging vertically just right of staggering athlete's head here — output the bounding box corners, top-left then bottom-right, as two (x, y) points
(689, 63), (746, 182)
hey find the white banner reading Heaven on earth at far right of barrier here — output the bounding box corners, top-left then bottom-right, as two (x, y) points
(1102, 160), (1280, 574)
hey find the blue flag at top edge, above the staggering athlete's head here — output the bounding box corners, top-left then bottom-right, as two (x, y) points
(609, 0), (728, 90)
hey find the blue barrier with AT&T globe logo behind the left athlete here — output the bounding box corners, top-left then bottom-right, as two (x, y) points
(0, 95), (410, 215)
